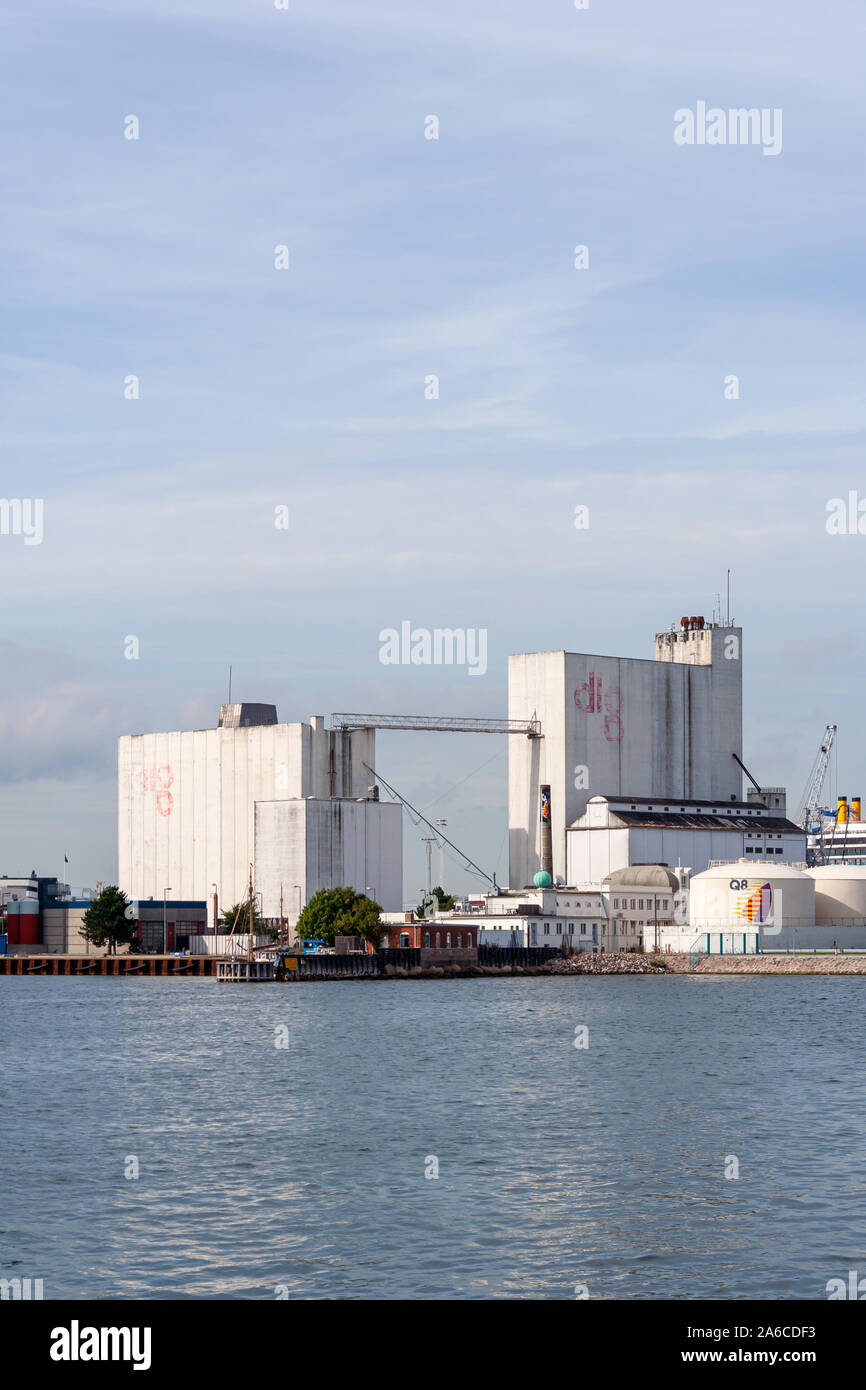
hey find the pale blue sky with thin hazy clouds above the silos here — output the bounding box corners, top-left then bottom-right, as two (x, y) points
(0, 0), (866, 898)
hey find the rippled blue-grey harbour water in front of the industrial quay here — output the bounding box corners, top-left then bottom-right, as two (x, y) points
(0, 976), (866, 1300)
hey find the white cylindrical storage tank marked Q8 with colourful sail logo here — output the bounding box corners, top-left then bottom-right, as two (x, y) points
(688, 859), (815, 931)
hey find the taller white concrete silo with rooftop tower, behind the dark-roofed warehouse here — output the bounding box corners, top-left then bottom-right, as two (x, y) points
(509, 619), (742, 887)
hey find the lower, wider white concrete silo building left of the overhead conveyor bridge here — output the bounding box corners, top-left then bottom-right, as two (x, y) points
(118, 705), (402, 924)
